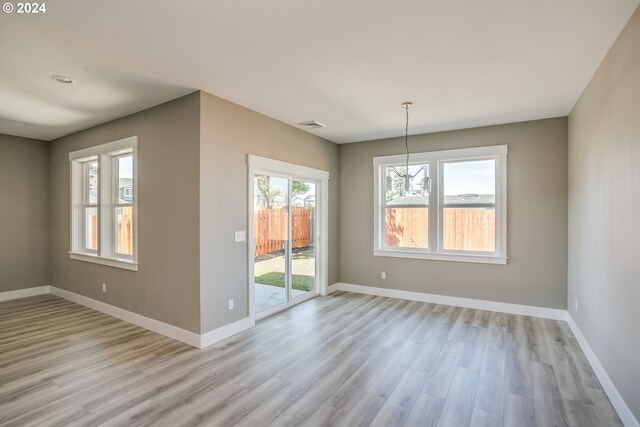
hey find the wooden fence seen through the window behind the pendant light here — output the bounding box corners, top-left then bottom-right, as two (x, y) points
(385, 208), (496, 252)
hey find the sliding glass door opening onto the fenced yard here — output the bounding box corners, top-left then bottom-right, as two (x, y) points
(253, 173), (317, 315)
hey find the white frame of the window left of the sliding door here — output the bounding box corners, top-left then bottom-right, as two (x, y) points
(69, 136), (138, 271)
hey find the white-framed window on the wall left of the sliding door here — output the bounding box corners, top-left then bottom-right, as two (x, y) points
(69, 136), (138, 270)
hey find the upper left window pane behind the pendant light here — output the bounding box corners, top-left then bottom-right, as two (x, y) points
(382, 165), (429, 206)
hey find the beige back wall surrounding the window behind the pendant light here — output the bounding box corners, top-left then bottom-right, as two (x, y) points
(339, 118), (567, 309)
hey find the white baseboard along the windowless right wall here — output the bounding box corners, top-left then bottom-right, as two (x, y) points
(566, 312), (640, 427)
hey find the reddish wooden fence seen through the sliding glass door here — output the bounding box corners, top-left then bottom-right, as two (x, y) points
(253, 207), (313, 256)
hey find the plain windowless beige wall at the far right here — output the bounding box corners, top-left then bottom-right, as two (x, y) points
(568, 4), (640, 419)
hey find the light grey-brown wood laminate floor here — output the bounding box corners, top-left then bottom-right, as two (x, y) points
(0, 292), (621, 427)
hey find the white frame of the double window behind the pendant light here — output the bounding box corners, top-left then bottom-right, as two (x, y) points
(373, 145), (508, 264)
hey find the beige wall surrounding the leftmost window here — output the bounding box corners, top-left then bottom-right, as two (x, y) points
(50, 92), (200, 333)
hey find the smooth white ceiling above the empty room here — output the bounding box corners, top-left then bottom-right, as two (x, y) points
(0, 0), (639, 143)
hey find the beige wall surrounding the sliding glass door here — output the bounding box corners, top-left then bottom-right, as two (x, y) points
(200, 92), (339, 333)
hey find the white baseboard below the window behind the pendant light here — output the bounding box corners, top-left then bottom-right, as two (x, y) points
(332, 283), (567, 320)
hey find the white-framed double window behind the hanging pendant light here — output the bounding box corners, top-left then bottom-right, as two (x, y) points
(373, 145), (507, 264)
